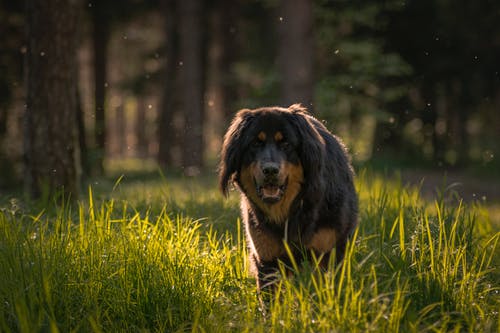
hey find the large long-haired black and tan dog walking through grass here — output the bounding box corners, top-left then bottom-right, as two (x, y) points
(219, 104), (357, 288)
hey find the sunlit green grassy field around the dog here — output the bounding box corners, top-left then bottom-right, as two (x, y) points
(0, 167), (500, 332)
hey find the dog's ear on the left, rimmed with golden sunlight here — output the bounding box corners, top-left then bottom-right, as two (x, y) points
(219, 109), (253, 196)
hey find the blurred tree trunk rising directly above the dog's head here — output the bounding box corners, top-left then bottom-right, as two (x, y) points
(278, 0), (314, 111)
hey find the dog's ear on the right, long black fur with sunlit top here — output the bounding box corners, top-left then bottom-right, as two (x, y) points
(288, 104), (326, 198)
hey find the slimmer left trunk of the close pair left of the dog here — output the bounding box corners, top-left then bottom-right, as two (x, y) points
(158, 0), (178, 168)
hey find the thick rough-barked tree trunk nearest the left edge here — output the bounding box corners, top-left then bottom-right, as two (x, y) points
(24, 0), (81, 198)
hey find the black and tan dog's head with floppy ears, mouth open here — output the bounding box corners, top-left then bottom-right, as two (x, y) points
(219, 105), (325, 215)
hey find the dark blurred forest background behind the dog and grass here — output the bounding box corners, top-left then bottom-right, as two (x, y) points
(0, 0), (500, 197)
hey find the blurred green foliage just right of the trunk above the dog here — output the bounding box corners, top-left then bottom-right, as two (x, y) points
(315, 1), (412, 160)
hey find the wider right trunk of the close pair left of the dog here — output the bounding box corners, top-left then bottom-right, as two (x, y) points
(178, 0), (205, 175)
